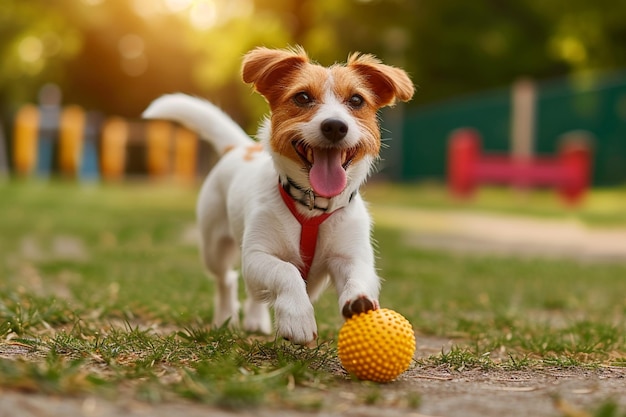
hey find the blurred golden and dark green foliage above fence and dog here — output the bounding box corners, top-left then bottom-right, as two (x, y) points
(0, 0), (626, 127)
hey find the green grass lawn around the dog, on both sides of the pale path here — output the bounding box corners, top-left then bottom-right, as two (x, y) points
(0, 182), (626, 410)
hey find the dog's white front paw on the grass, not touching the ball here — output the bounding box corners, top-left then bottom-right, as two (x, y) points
(274, 303), (317, 345)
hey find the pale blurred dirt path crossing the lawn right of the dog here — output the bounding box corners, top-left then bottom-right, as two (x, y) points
(372, 205), (626, 262)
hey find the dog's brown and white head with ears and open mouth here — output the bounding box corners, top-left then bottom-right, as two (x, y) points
(242, 48), (413, 198)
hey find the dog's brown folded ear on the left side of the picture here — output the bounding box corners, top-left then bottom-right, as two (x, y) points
(241, 47), (309, 101)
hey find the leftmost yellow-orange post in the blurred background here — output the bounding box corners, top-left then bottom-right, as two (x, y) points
(13, 104), (39, 175)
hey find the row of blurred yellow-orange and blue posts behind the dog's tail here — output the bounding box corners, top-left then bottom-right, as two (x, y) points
(11, 105), (199, 182)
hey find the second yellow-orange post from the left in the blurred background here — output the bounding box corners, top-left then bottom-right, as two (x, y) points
(58, 106), (85, 176)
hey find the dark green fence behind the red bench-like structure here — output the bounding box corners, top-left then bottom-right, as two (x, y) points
(400, 72), (626, 185)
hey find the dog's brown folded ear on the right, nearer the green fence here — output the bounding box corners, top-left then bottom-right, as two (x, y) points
(347, 52), (414, 107)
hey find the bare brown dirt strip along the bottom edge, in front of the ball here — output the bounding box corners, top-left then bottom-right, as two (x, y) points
(0, 362), (626, 417)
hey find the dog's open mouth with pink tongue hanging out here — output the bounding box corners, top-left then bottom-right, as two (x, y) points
(292, 141), (358, 198)
